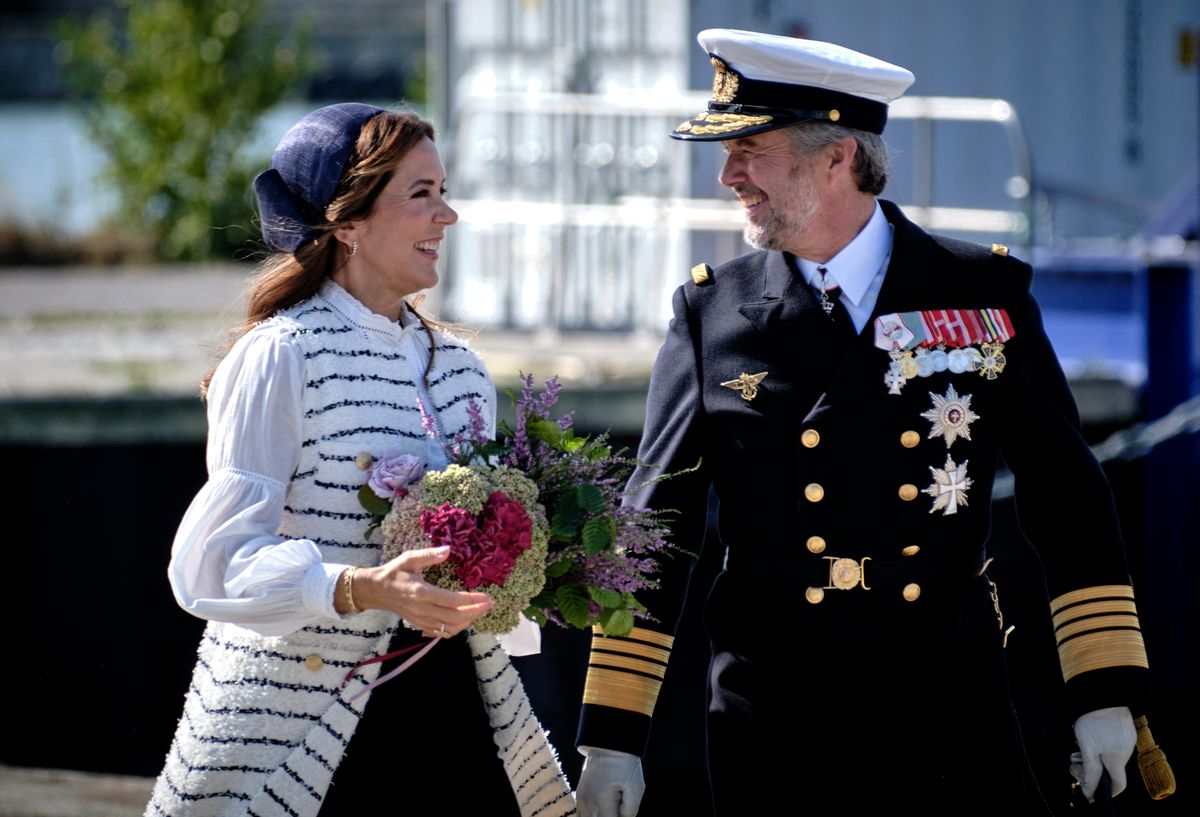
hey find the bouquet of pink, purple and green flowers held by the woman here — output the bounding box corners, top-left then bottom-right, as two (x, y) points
(359, 376), (672, 636)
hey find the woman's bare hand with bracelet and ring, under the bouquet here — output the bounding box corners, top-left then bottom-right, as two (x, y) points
(337, 547), (493, 638)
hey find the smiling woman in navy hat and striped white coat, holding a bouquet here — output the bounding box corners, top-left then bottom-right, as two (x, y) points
(146, 103), (574, 817)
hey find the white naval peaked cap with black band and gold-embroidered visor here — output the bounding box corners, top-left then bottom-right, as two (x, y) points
(671, 29), (916, 142)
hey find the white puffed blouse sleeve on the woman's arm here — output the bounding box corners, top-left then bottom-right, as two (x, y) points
(168, 322), (347, 636)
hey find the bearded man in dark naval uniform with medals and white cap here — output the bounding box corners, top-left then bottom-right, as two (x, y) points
(578, 30), (1147, 817)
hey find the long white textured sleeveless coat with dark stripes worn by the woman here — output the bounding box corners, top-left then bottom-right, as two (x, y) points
(145, 283), (575, 817)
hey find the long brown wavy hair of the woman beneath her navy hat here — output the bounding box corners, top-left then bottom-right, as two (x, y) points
(200, 110), (438, 397)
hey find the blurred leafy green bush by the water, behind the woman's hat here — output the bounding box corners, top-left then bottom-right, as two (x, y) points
(60, 0), (312, 260)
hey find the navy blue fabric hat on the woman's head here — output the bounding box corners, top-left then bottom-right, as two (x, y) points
(254, 102), (384, 252)
